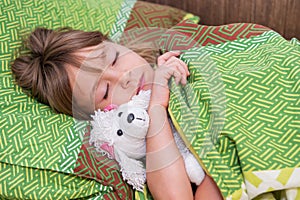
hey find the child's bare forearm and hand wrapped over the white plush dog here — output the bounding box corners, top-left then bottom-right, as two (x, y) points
(146, 52), (193, 200)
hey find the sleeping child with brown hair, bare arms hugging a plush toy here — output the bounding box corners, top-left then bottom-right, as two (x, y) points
(12, 28), (222, 199)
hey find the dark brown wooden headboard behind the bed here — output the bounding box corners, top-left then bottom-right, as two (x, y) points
(144, 0), (300, 39)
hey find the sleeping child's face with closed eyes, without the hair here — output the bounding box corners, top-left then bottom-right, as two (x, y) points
(67, 41), (154, 113)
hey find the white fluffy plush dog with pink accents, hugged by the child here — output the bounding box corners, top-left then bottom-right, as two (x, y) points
(90, 90), (205, 191)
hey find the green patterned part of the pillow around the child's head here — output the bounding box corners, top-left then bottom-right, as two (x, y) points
(0, 0), (135, 199)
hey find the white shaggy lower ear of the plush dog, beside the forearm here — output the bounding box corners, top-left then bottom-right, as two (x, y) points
(115, 149), (146, 192)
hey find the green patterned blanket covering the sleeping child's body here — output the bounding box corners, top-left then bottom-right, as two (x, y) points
(169, 31), (300, 199)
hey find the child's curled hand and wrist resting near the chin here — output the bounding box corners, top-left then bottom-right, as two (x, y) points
(151, 51), (190, 108)
